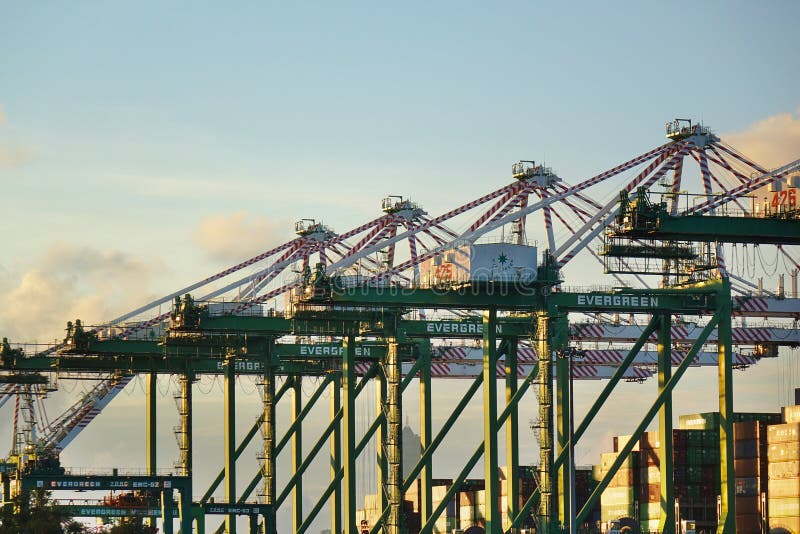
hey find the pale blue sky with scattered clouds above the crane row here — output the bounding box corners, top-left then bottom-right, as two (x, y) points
(0, 1), (800, 532)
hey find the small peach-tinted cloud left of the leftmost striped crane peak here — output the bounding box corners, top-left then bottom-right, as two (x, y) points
(194, 210), (292, 263)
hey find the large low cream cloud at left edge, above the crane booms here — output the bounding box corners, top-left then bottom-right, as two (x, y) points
(0, 244), (161, 343)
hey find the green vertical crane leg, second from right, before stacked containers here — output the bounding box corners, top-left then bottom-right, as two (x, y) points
(648, 313), (675, 534)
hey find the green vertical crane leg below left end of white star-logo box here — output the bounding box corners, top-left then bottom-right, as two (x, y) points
(483, 308), (502, 534)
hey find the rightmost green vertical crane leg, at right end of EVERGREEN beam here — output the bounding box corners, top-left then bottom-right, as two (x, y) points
(717, 278), (736, 534)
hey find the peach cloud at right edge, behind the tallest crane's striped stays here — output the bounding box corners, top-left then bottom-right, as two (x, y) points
(722, 109), (800, 172)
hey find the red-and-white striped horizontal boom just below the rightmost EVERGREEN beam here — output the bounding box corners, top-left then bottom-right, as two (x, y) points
(570, 323), (800, 346)
